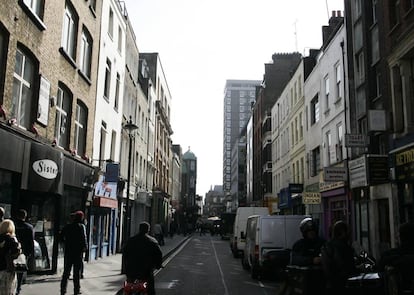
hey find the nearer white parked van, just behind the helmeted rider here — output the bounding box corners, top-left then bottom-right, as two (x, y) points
(242, 215), (307, 279)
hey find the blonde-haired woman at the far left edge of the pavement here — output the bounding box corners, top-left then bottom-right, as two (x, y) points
(0, 219), (21, 295)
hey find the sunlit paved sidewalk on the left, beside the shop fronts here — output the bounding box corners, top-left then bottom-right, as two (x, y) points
(21, 235), (190, 295)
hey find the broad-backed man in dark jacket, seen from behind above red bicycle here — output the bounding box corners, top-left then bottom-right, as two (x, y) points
(123, 222), (162, 295)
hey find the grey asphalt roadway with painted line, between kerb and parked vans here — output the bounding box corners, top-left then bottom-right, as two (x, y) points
(156, 233), (280, 295)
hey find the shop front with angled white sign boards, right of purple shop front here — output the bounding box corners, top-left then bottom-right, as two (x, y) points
(348, 154), (396, 257)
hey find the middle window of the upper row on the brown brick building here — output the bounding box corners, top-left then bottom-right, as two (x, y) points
(61, 1), (79, 59)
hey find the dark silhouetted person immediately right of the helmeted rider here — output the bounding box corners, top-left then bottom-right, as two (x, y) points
(322, 221), (357, 295)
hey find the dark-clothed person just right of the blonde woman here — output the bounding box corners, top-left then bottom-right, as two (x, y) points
(15, 209), (35, 295)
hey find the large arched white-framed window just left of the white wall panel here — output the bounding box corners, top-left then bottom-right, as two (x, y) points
(11, 48), (36, 129)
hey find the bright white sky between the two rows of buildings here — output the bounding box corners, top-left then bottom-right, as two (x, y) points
(125, 0), (343, 196)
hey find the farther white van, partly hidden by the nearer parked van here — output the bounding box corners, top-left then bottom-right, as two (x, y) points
(230, 207), (269, 258)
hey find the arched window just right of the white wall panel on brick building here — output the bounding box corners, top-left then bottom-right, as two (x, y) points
(55, 84), (73, 149)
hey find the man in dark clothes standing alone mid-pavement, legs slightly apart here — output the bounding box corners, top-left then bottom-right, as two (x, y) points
(60, 211), (88, 295)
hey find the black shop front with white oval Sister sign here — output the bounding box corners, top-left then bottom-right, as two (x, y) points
(0, 128), (94, 273)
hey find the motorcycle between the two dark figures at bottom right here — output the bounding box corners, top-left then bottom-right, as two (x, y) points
(346, 251), (384, 295)
